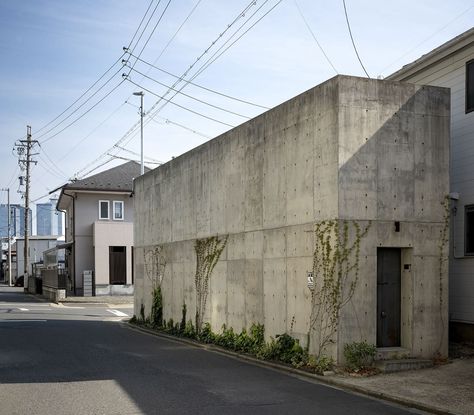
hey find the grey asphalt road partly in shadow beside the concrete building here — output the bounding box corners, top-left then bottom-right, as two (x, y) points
(0, 292), (420, 415)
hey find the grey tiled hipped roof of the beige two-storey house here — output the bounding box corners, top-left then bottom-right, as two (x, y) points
(63, 161), (150, 192)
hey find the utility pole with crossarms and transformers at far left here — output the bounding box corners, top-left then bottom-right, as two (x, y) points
(16, 125), (38, 291)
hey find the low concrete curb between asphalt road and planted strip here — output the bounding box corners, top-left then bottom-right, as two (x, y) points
(126, 322), (459, 415)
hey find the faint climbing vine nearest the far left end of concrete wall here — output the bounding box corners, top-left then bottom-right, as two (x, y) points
(143, 245), (166, 327)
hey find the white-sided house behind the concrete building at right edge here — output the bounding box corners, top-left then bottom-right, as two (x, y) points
(387, 28), (474, 341)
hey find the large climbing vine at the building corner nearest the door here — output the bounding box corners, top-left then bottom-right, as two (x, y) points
(308, 219), (371, 358)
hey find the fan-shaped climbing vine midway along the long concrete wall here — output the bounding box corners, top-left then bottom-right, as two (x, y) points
(194, 236), (228, 334)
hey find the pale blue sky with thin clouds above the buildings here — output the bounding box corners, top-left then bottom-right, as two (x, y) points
(0, 0), (474, 219)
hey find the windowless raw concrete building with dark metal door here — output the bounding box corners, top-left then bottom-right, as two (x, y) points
(134, 76), (450, 361)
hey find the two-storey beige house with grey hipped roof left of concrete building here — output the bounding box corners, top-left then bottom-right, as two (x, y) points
(57, 161), (144, 296)
